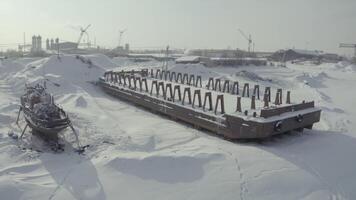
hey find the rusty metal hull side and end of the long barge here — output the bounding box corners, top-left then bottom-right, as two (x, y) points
(98, 78), (321, 139)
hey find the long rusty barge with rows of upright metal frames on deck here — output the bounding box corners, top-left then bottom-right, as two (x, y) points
(98, 69), (321, 139)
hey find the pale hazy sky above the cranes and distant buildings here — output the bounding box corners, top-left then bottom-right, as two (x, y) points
(0, 0), (356, 54)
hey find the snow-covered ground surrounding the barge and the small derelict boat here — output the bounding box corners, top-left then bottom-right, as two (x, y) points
(0, 55), (356, 200)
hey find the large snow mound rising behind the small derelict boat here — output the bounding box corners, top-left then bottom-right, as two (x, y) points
(8, 55), (106, 94)
